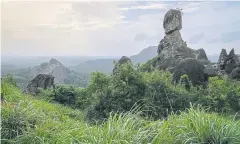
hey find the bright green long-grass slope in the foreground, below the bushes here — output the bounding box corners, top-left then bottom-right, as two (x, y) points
(1, 83), (240, 144)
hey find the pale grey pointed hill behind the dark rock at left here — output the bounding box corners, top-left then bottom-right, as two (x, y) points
(3, 58), (89, 88)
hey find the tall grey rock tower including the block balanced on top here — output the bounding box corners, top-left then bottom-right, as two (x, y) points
(154, 9), (209, 69)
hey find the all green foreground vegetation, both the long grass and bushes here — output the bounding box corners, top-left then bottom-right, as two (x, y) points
(1, 63), (240, 144)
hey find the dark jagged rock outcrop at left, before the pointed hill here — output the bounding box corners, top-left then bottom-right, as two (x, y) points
(24, 74), (54, 95)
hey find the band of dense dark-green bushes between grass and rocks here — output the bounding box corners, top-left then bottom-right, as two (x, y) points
(15, 62), (240, 121)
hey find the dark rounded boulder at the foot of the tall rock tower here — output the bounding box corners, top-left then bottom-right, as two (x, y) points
(172, 59), (207, 86)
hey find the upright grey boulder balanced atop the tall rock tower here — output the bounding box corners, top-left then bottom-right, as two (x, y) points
(163, 9), (182, 34)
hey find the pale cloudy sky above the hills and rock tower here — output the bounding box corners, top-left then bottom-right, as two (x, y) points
(1, 0), (240, 56)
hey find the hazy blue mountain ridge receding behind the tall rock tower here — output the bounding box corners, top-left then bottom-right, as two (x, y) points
(69, 46), (157, 73)
